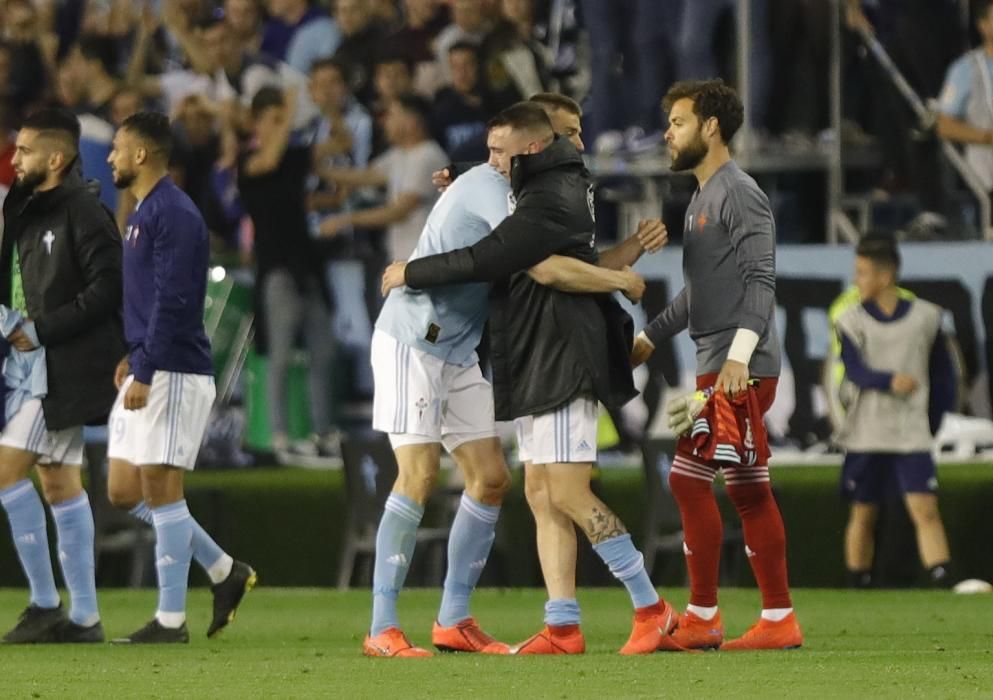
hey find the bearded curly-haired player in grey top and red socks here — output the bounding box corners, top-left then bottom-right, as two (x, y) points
(632, 80), (803, 649)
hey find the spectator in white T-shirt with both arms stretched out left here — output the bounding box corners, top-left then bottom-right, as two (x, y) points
(320, 94), (448, 260)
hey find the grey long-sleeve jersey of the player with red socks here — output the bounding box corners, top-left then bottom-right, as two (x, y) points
(645, 161), (780, 377)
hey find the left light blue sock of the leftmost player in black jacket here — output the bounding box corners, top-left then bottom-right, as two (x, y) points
(0, 479), (59, 608)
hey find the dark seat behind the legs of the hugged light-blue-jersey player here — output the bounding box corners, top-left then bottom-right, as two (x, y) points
(338, 433), (451, 590)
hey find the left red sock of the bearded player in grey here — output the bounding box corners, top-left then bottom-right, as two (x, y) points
(669, 465), (724, 608)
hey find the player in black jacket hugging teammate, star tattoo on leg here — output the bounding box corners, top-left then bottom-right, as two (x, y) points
(384, 103), (675, 654)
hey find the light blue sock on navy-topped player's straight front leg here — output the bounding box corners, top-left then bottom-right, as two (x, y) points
(152, 500), (193, 627)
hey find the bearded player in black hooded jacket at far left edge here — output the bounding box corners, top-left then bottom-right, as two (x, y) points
(0, 109), (124, 643)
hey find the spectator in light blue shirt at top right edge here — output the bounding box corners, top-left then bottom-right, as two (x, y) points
(938, 0), (993, 196)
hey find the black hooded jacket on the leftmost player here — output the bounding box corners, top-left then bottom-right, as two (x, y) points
(0, 161), (126, 430)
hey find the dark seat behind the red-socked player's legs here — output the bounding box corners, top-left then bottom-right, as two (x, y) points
(641, 439), (745, 584)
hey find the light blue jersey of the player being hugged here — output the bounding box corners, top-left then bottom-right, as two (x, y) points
(376, 164), (511, 367)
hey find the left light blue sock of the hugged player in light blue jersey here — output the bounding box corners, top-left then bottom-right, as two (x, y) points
(369, 493), (424, 636)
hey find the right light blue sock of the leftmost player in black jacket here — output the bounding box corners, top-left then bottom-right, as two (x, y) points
(52, 491), (100, 627)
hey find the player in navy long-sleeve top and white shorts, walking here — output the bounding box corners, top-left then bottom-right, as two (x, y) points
(108, 112), (256, 644)
